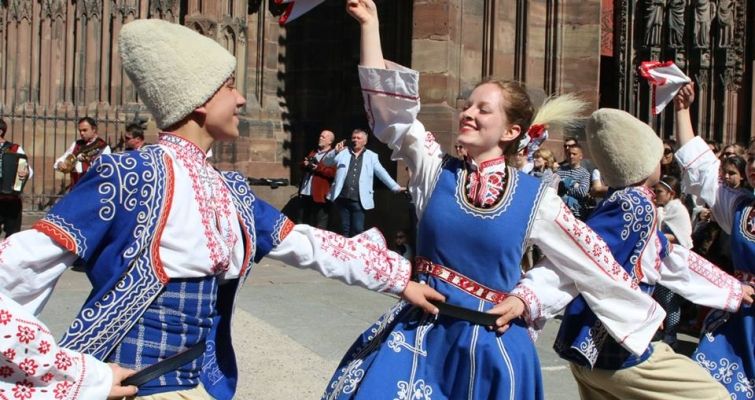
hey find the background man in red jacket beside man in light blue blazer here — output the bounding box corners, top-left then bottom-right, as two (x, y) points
(299, 129), (336, 229)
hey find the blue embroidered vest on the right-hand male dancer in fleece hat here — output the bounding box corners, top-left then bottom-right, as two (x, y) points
(553, 187), (668, 370)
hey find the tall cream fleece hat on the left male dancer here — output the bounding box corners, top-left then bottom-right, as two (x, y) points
(118, 19), (236, 129)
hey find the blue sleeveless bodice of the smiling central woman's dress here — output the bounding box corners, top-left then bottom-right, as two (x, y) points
(417, 157), (545, 309)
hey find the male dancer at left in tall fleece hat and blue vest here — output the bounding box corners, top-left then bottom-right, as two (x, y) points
(0, 20), (442, 399)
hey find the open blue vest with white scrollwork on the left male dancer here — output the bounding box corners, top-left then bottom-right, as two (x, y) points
(34, 145), (293, 399)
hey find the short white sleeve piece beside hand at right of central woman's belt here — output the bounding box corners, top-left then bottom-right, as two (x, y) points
(511, 258), (579, 330)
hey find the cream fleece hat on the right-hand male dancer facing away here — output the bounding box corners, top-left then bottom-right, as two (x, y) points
(586, 108), (663, 188)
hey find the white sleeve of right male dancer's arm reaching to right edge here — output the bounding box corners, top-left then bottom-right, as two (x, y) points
(659, 246), (742, 312)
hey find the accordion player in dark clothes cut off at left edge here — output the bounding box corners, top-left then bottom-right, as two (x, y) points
(0, 119), (31, 237)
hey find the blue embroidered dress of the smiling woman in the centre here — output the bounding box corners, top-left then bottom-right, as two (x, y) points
(323, 158), (543, 399)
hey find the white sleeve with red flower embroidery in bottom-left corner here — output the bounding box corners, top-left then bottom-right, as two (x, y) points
(0, 294), (113, 400)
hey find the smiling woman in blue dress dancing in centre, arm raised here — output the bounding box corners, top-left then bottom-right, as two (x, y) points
(323, 0), (663, 400)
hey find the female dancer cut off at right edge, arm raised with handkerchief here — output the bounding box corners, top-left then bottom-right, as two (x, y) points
(675, 84), (755, 400)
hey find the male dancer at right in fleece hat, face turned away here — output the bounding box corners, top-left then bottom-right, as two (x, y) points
(545, 109), (753, 400)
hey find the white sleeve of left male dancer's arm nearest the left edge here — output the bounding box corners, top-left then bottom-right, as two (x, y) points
(0, 229), (76, 314)
